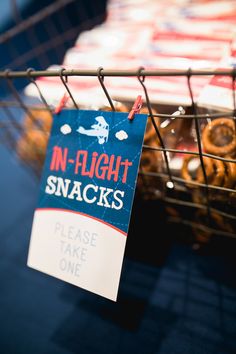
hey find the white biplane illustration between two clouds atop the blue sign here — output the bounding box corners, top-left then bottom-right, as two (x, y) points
(77, 116), (109, 144)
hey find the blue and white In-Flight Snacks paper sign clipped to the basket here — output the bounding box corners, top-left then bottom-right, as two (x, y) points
(28, 110), (147, 300)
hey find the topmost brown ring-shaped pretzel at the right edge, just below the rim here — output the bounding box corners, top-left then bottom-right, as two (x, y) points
(202, 118), (236, 156)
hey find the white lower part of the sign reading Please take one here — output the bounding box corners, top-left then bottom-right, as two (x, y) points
(28, 209), (126, 301)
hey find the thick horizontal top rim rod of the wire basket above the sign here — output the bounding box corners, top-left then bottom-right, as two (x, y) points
(0, 68), (236, 78)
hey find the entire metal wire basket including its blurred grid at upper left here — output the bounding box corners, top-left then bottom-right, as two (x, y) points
(0, 0), (236, 243)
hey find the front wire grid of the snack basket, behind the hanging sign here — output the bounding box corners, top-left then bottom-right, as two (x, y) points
(0, 68), (236, 246)
